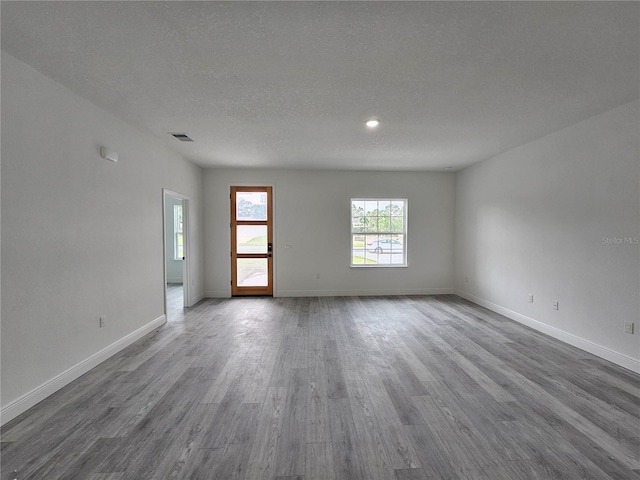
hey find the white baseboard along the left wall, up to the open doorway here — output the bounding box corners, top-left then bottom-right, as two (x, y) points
(0, 314), (167, 425)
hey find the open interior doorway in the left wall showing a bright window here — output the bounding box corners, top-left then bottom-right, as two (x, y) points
(162, 189), (190, 319)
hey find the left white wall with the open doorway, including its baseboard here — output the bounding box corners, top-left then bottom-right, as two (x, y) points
(1, 52), (204, 422)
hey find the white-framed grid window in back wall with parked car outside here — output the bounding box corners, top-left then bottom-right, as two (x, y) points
(351, 198), (407, 267)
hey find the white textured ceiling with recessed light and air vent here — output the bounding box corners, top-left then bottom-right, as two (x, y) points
(1, 1), (640, 170)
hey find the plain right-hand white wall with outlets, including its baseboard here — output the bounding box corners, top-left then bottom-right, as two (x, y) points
(455, 101), (640, 371)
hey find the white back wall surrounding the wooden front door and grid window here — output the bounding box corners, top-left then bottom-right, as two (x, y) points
(204, 169), (455, 297)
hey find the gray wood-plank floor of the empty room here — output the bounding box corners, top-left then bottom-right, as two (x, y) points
(1, 295), (640, 480)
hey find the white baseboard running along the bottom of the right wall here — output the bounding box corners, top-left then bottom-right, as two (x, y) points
(455, 290), (640, 373)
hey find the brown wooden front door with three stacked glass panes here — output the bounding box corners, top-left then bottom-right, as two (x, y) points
(231, 187), (273, 296)
